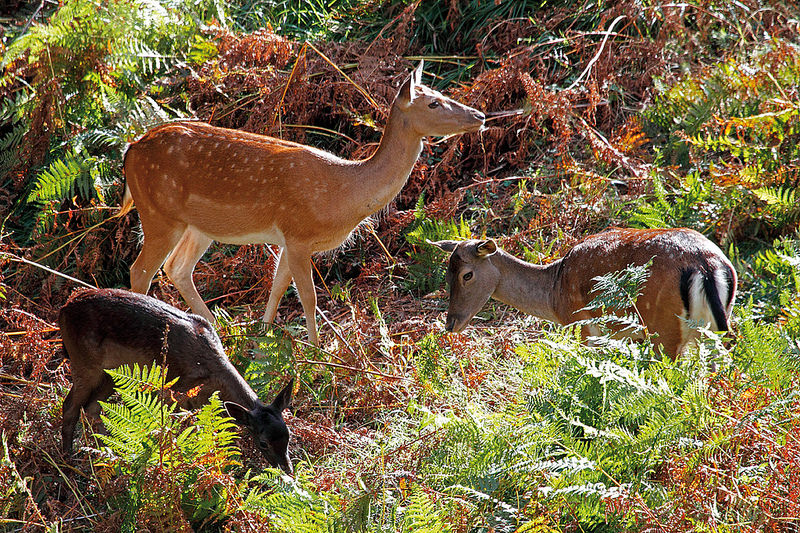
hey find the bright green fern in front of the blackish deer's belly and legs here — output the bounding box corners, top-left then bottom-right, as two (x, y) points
(96, 365), (244, 531)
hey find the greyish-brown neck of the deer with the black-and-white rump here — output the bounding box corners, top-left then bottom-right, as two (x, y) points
(492, 250), (561, 322)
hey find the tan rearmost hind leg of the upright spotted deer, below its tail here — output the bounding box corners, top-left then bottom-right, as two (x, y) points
(131, 213), (186, 294)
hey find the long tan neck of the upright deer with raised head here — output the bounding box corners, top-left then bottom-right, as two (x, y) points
(351, 106), (422, 220)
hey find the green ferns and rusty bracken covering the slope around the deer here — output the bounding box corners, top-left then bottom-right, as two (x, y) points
(0, 0), (800, 533)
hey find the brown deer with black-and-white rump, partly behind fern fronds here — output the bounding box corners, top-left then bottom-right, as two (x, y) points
(432, 228), (736, 359)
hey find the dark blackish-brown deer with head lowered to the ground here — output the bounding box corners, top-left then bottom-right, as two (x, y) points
(58, 289), (294, 473)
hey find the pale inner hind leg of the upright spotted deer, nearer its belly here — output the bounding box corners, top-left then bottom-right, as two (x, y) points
(164, 227), (214, 323)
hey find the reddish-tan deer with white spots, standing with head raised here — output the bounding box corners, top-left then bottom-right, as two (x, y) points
(119, 63), (484, 345)
